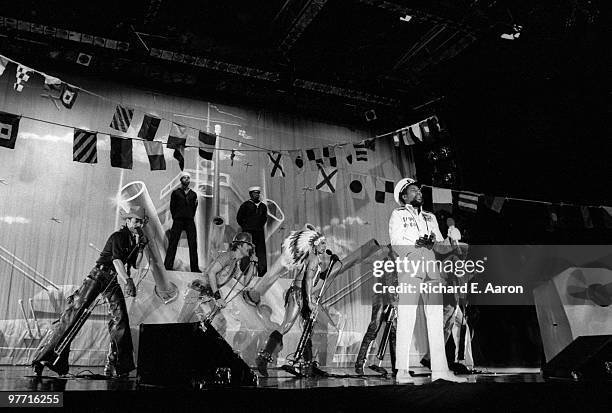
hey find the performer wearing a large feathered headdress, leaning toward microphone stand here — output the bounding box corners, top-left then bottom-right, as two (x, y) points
(256, 224), (327, 377)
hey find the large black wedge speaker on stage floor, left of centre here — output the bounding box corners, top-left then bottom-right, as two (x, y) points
(138, 323), (257, 388)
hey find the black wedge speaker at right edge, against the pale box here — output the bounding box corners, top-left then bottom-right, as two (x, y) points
(542, 335), (612, 380)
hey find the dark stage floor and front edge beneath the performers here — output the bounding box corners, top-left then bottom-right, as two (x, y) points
(0, 366), (612, 412)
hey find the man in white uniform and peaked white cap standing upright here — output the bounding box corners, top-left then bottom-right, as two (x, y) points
(389, 178), (467, 383)
